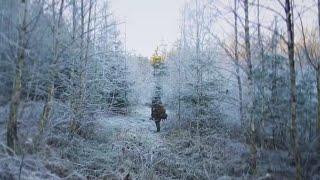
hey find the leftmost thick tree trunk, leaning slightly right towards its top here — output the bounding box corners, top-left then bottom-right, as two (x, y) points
(7, 0), (28, 154)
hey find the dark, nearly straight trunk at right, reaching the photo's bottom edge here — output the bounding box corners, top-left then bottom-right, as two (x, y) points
(285, 0), (302, 180)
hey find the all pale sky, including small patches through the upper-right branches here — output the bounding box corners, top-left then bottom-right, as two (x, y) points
(110, 0), (316, 57)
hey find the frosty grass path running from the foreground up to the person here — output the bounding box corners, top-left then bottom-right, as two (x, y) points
(98, 106), (178, 179)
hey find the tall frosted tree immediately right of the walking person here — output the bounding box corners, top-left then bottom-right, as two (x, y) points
(165, 0), (225, 135)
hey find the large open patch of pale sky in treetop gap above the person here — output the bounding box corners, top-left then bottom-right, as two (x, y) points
(111, 0), (186, 57)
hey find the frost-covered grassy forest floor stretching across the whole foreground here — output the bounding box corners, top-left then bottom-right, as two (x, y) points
(0, 104), (298, 180)
